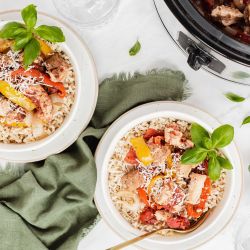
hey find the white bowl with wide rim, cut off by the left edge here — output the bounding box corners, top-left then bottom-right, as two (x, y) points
(0, 10), (98, 162)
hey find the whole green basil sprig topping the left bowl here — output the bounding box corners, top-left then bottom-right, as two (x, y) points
(0, 4), (65, 68)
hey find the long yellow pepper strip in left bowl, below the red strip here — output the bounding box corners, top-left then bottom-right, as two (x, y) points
(0, 81), (36, 111)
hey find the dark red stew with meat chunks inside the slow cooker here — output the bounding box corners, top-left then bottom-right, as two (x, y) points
(192, 0), (250, 44)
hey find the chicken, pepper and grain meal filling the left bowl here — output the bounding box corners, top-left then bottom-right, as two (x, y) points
(0, 39), (76, 143)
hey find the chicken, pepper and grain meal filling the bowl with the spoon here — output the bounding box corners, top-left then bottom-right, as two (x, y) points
(108, 118), (226, 234)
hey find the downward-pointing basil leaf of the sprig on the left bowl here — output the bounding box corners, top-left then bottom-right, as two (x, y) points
(24, 38), (41, 68)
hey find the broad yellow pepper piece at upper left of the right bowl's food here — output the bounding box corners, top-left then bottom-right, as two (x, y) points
(130, 137), (153, 166)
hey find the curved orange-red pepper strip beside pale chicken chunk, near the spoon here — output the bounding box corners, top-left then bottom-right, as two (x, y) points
(186, 177), (211, 219)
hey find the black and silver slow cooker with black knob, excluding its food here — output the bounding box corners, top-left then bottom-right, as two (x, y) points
(154, 0), (250, 85)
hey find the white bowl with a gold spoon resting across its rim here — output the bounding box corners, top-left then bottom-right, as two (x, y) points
(95, 102), (242, 250)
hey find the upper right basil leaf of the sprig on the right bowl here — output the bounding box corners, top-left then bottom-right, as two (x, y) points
(211, 124), (234, 148)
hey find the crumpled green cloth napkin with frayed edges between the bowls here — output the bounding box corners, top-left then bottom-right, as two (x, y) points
(0, 69), (189, 250)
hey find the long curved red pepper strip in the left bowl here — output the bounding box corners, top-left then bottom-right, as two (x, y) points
(11, 68), (66, 98)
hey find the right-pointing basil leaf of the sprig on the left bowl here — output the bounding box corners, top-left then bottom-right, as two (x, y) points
(34, 25), (65, 43)
